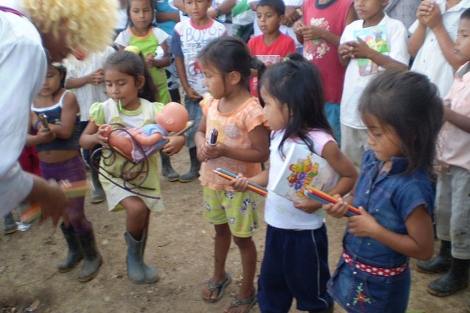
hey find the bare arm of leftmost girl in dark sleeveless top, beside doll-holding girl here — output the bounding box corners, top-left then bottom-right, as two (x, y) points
(49, 92), (80, 139)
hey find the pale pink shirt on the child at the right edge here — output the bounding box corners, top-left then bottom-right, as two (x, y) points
(437, 62), (470, 170)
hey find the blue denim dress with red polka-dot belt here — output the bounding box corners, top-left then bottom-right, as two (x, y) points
(328, 150), (434, 313)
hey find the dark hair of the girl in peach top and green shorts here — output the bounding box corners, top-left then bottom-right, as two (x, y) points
(197, 36), (266, 89)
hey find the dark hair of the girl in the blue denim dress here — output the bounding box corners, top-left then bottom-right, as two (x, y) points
(359, 69), (444, 174)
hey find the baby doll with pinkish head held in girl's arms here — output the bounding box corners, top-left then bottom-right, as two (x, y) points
(103, 102), (189, 163)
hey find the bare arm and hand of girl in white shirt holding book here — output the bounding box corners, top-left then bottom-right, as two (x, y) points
(294, 141), (359, 216)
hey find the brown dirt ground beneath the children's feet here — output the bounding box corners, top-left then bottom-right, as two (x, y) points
(0, 149), (470, 313)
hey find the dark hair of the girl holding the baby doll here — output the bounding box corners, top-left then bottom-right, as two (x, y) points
(103, 50), (157, 102)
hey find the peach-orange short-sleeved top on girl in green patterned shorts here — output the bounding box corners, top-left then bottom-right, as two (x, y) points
(199, 94), (266, 190)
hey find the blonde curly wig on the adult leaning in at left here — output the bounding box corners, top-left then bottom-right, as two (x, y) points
(23, 0), (117, 54)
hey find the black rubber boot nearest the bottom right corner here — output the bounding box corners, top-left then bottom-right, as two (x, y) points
(427, 258), (470, 297)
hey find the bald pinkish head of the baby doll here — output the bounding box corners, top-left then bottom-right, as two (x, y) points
(155, 102), (189, 132)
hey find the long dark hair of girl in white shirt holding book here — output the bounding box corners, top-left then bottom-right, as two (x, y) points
(259, 53), (334, 157)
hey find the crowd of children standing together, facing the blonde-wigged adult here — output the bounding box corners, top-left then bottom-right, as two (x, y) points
(0, 0), (470, 313)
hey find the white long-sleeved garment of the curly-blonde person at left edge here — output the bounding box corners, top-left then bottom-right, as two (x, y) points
(0, 12), (47, 216)
